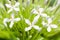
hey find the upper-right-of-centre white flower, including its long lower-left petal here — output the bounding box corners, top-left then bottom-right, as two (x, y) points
(32, 6), (47, 22)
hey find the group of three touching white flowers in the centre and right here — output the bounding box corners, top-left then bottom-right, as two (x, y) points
(25, 7), (57, 32)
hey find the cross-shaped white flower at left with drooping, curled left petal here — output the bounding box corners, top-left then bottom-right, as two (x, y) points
(3, 14), (20, 28)
